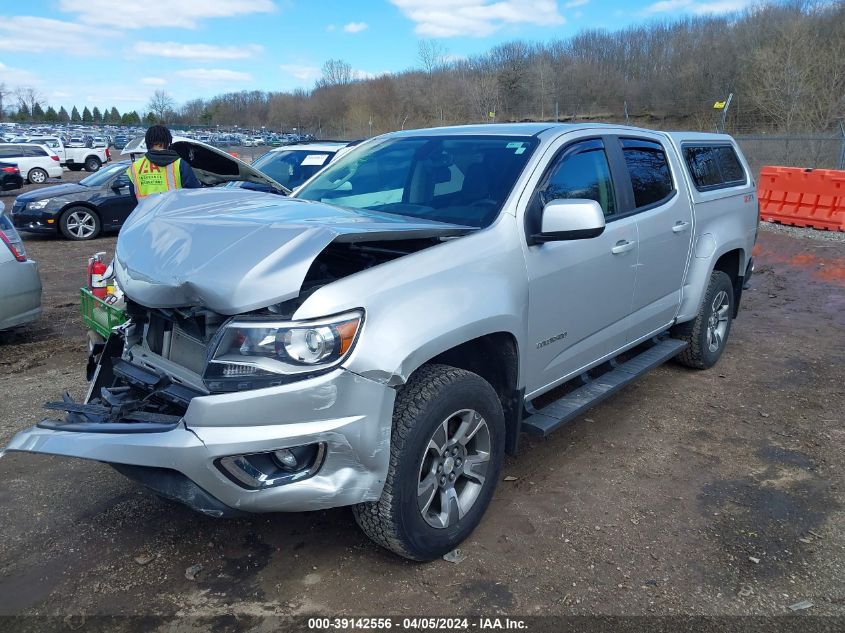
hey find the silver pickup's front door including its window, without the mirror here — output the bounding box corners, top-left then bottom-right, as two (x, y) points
(525, 138), (638, 397)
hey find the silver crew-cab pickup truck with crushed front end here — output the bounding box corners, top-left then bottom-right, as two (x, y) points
(7, 124), (758, 560)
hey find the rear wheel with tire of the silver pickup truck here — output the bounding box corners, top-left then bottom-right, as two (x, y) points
(672, 270), (734, 369)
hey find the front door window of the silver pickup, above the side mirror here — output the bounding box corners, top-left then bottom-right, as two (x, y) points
(539, 139), (616, 217)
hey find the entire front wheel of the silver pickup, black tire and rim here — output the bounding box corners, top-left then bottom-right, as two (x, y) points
(353, 365), (505, 561)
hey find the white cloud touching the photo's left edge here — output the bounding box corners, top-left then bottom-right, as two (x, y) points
(0, 15), (109, 56)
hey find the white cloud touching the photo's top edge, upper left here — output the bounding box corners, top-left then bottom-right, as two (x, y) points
(59, 0), (276, 29)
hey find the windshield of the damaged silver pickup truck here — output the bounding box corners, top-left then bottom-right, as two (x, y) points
(295, 136), (537, 227)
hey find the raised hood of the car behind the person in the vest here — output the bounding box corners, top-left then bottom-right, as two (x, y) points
(120, 136), (290, 195)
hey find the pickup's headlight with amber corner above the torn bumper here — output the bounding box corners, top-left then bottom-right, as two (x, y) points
(203, 310), (364, 391)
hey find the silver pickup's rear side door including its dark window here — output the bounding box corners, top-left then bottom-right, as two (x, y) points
(617, 133), (693, 341)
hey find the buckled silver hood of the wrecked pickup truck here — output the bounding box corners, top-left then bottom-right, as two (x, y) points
(115, 188), (475, 315)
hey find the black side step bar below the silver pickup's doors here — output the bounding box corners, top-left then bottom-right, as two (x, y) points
(522, 338), (687, 437)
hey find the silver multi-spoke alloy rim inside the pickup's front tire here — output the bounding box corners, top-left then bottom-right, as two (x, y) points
(417, 409), (491, 529)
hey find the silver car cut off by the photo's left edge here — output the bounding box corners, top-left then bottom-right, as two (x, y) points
(0, 202), (41, 330)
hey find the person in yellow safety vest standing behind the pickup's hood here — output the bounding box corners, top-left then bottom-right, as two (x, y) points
(126, 125), (202, 202)
